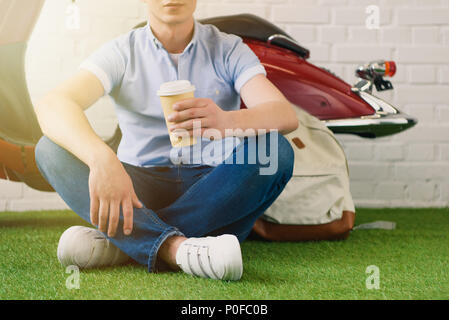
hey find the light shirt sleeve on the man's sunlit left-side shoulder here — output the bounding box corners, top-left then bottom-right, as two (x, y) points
(78, 37), (126, 95)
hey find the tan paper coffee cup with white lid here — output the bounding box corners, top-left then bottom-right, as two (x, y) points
(157, 80), (196, 147)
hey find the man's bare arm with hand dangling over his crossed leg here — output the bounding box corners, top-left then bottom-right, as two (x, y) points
(35, 70), (142, 237)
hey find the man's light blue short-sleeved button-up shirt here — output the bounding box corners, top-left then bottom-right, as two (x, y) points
(80, 21), (266, 167)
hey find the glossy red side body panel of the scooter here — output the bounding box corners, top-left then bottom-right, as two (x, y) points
(244, 39), (375, 120)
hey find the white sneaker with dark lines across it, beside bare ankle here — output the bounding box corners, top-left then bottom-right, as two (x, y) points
(176, 234), (243, 280)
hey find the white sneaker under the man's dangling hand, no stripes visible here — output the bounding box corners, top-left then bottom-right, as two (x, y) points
(57, 226), (129, 269)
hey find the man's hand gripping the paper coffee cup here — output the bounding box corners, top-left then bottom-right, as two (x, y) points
(168, 98), (232, 137)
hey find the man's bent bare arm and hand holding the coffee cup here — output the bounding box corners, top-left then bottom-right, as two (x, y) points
(163, 74), (298, 139)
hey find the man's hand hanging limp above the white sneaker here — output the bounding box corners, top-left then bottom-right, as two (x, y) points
(89, 155), (143, 237)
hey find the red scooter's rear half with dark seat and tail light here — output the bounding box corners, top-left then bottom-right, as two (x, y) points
(202, 14), (416, 138)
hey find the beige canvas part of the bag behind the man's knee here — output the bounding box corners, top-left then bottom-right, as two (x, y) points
(261, 108), (355, 225)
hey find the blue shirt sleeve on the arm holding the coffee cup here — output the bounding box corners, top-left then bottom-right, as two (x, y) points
(225, 36), (267, 94)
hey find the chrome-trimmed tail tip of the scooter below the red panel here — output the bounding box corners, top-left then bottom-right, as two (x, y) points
(323, 92), (418, 138)
